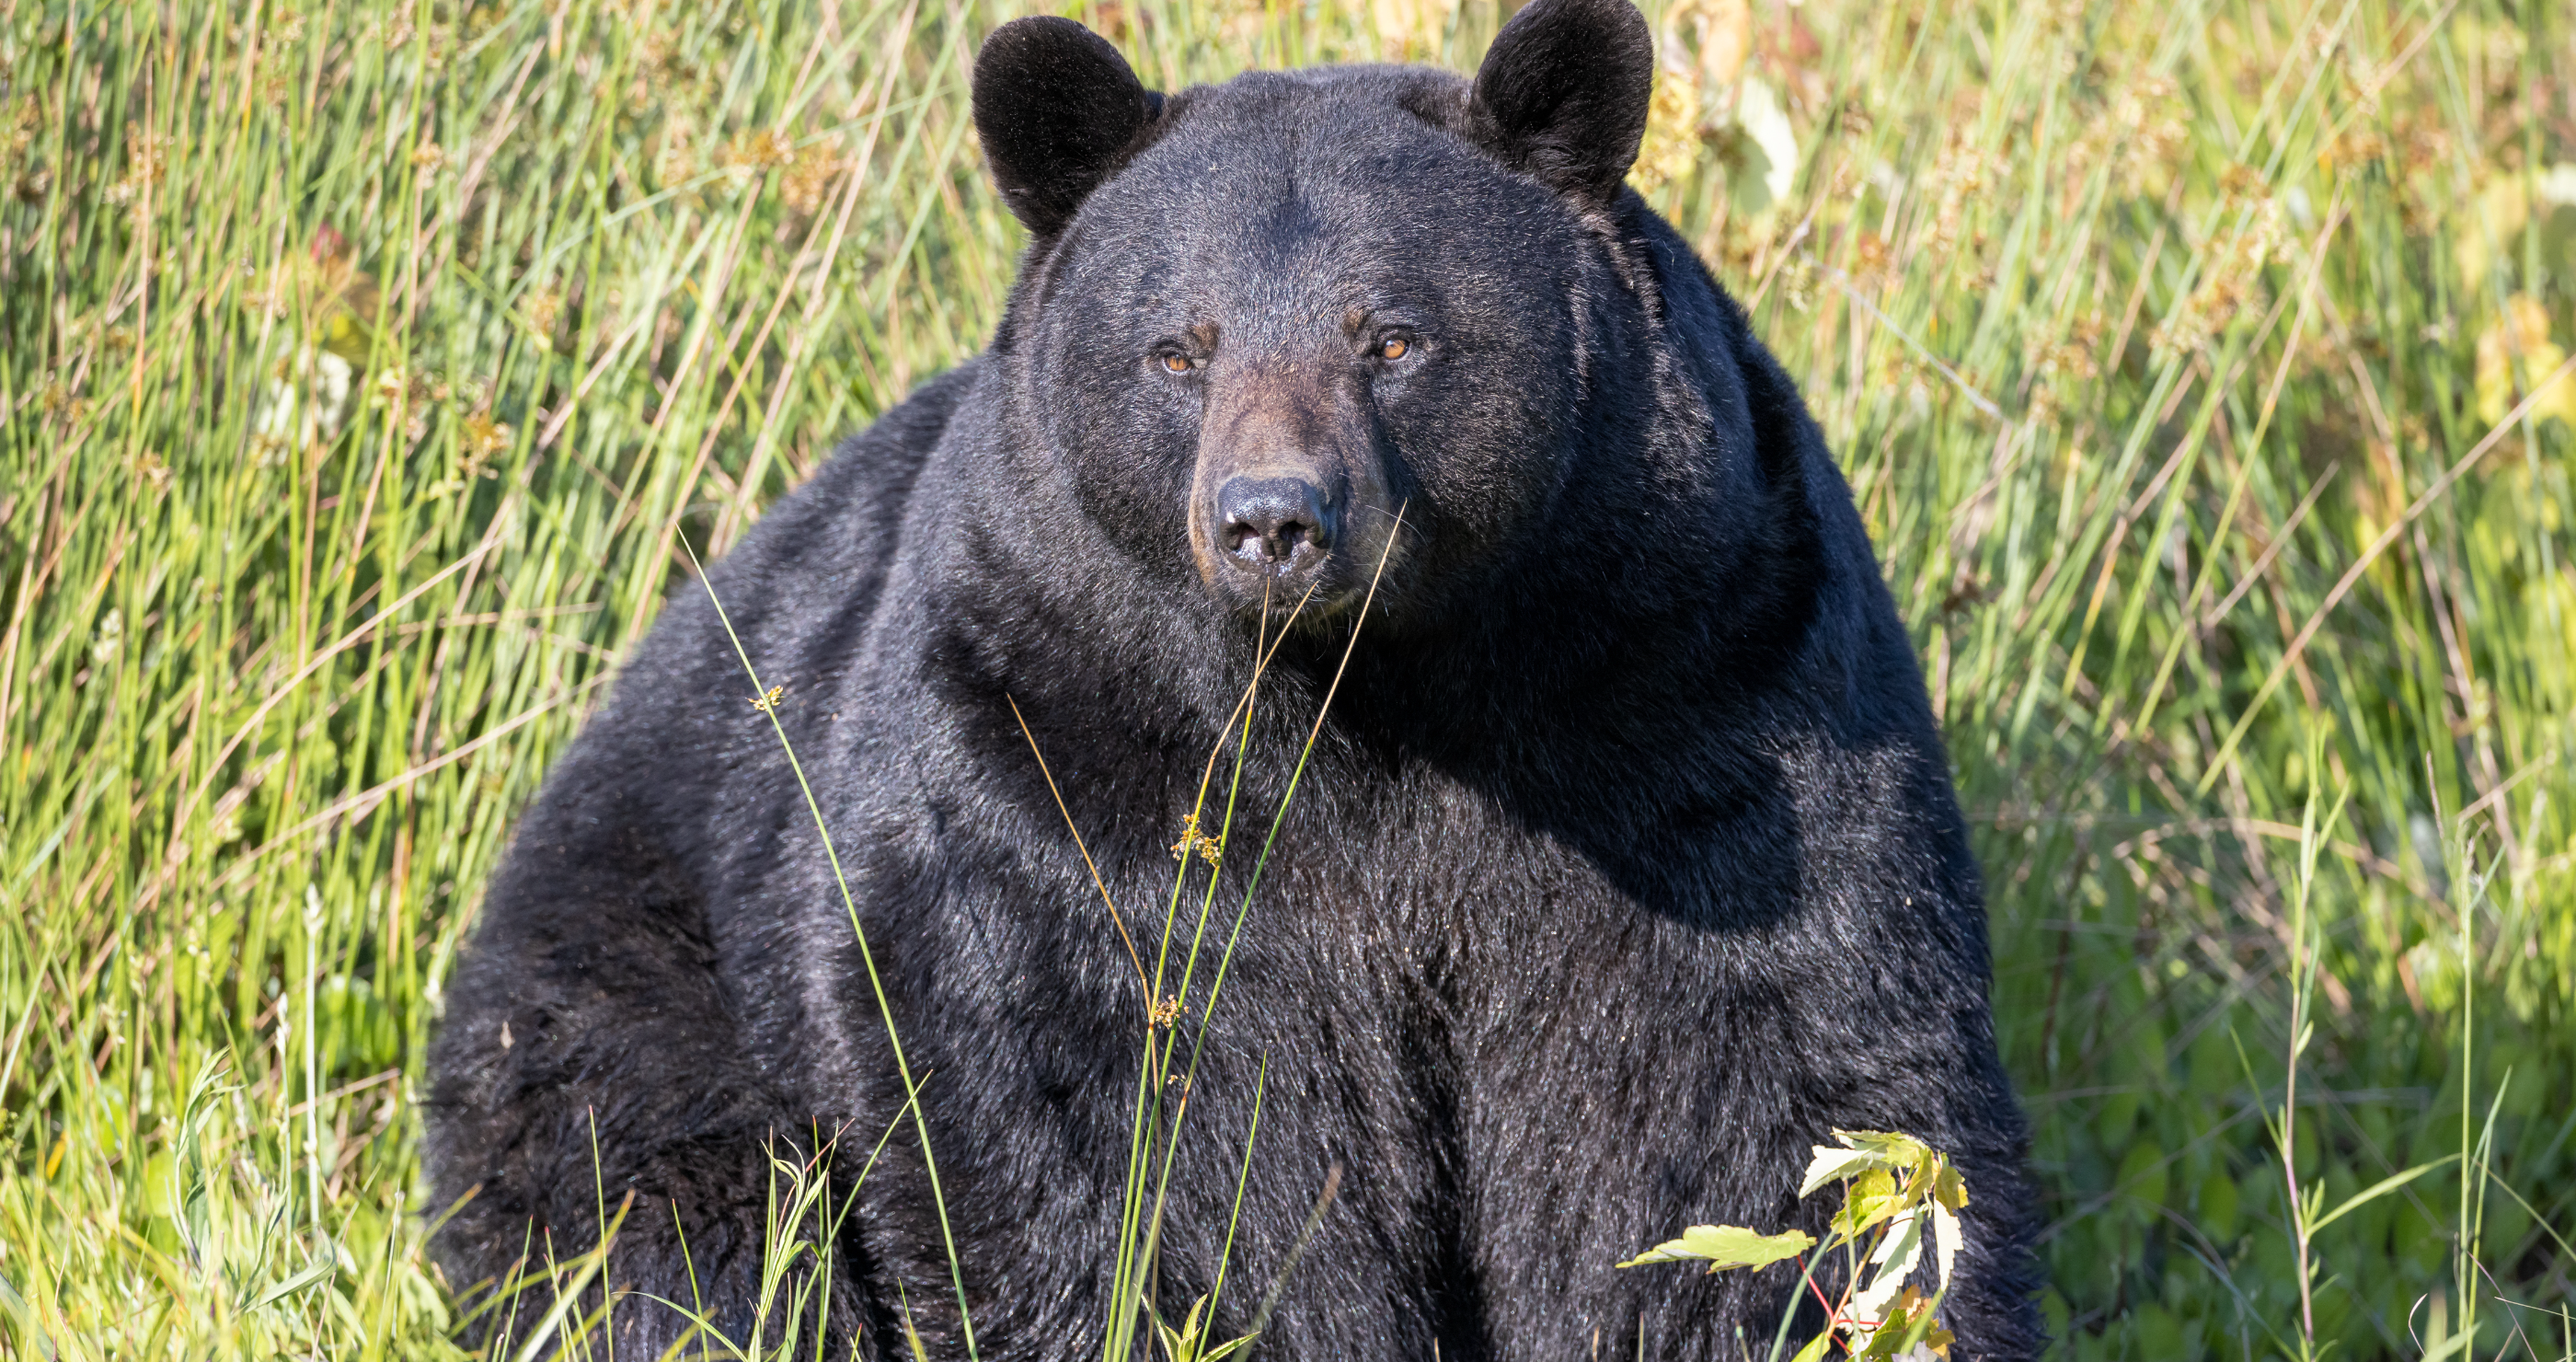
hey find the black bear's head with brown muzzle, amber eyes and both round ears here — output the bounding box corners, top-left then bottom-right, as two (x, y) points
(973, 0), (1654, 620)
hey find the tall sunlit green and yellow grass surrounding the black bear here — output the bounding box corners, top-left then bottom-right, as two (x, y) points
(0, 0), (2576, 1359)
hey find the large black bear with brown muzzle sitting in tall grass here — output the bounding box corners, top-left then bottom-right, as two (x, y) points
(428, 0), (2041, 1362)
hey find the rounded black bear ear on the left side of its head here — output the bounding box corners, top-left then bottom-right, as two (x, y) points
(973, 16), (1162, 237)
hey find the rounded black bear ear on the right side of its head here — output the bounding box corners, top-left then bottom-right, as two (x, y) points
(1468, 0), (1654, 206)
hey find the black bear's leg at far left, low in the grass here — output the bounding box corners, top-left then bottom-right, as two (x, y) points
(428, 780), (866, 1356)
